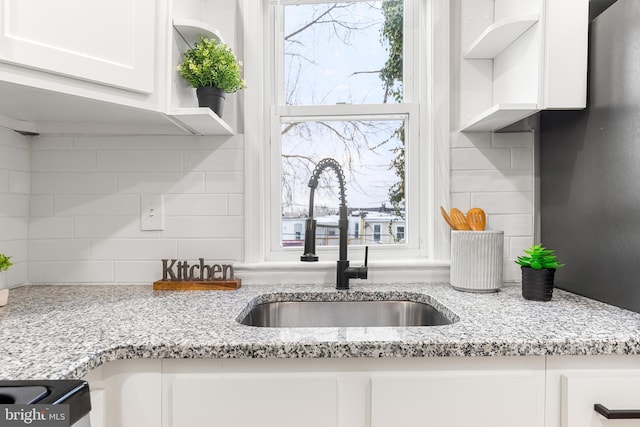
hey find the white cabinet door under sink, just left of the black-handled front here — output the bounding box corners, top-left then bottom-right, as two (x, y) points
(371, 371), (544, 427)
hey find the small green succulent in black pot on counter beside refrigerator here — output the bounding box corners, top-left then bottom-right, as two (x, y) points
(515, 244), (564, 301)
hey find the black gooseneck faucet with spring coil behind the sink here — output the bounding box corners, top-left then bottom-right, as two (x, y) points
(300, 158), (369, 290)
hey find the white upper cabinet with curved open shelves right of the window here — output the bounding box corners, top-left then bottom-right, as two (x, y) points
(459, 0), (589, 132)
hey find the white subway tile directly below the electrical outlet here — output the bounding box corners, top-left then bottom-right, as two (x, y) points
(91, 239), (178, 261)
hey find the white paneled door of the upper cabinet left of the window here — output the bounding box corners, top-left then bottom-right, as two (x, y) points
(0, 0), (156, 93)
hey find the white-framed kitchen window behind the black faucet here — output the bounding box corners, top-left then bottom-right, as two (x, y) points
(244, 0), (449, 270)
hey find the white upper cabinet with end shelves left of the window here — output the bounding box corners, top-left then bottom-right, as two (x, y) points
(0, 0), (237, 135)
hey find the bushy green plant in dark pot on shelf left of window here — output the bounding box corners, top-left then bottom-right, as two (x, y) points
(178, 37), (246, 117)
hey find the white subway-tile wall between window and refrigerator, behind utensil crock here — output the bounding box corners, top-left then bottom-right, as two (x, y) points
(451, 132), (535, 281)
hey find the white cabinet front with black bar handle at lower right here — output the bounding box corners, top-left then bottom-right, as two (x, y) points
(562, 371), (640, 427)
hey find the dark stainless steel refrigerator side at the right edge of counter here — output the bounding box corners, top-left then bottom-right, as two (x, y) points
(540, 0), (640, 312)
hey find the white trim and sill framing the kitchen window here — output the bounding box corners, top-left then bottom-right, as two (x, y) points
(236, 0), (450, 283)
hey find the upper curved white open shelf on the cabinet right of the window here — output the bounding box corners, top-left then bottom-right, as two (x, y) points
(463, 15), (538, 59)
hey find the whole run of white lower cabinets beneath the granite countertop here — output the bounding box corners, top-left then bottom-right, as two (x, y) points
(85, 356), (640, 427)
